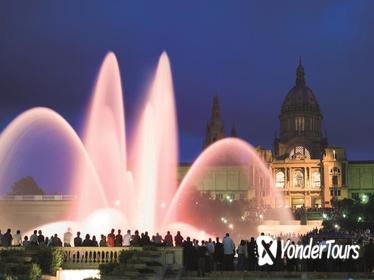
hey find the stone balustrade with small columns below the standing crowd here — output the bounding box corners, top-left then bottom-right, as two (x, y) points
(59, 247), (183, 269)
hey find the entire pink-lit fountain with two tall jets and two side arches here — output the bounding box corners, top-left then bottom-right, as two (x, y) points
(0, 53), (291, 240)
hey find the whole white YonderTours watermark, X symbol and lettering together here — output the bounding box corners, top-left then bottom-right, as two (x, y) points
(256, 235), (360, 266)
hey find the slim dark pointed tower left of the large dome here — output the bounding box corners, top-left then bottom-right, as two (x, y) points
(203, 96), (225, 149)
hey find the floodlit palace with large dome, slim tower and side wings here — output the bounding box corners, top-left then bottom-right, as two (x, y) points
(178, 59), (374, 208)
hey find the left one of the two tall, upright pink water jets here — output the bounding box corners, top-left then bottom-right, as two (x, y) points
(80, 53), (127, 211)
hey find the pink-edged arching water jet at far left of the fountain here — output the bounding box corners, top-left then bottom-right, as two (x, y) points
(0, 107), (107, 215)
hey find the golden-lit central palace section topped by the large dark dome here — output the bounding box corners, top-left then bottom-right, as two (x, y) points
(270, 59), (346, 208)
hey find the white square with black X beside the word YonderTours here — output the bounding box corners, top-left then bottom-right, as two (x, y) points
(256, 235), (277, 266)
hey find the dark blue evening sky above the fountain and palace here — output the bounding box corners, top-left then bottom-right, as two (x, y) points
(0, 0), (374, 161)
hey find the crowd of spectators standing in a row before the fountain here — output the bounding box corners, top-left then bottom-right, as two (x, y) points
(0, 228), (374, 276)
